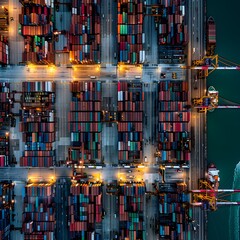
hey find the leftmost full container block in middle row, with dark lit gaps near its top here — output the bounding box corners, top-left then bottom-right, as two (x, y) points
(19, 81), (56, 167)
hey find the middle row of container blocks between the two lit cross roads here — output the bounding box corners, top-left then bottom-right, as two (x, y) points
(3, 81), (190, 167)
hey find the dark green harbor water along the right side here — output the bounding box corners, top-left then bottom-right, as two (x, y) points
(207, 0), (240, 240)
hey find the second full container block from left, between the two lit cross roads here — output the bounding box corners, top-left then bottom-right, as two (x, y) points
(68, 81), (102, 163)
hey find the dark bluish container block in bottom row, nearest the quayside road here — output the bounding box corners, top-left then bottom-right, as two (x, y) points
(159, 183), (191, 240)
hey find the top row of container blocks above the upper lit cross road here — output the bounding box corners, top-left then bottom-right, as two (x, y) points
(15, 0), (188, 64)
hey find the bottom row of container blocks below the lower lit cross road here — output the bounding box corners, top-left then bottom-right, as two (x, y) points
(0, 181), (192, 240)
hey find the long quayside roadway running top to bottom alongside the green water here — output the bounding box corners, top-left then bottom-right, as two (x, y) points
(188, 0), (207, 240)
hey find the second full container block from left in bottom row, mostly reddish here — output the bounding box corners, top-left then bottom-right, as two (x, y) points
(68, 182), (102, 240)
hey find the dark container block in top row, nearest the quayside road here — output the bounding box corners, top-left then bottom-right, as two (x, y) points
(157, 0), (188, 64)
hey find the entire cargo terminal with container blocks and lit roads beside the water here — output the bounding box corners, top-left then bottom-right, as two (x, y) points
(0, 0), (219, 240)
